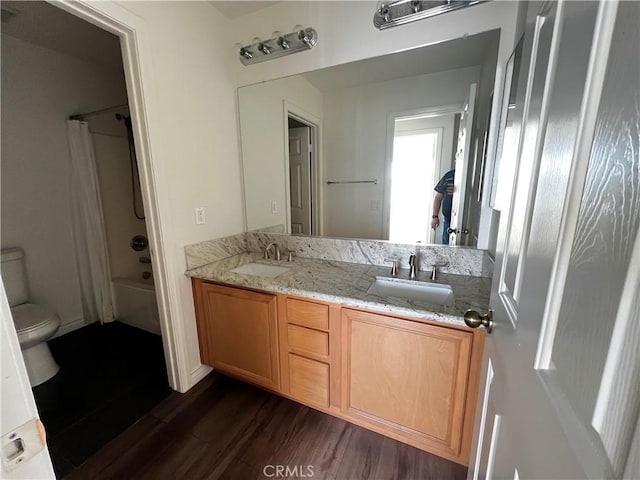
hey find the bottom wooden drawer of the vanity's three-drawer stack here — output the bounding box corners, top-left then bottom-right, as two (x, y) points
(289, 353), (329, 408)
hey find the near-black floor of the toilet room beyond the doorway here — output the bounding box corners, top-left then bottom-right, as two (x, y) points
(33, 322), (171, 478)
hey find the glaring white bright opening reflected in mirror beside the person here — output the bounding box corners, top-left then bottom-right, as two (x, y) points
(389, 119), (442, 243)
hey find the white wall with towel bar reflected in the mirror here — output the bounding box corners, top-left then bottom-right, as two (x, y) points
(323, 67), (479, 239)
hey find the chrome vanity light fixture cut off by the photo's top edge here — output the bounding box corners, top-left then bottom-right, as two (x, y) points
(373, 0), (487, 30)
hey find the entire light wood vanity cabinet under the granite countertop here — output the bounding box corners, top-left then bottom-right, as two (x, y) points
(193, 279), (484, 465)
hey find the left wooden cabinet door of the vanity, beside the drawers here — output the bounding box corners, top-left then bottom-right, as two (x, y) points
(202, 283), (280, 389)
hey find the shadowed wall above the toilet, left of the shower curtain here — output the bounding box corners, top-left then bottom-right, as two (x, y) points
(1, 35), (126, 332)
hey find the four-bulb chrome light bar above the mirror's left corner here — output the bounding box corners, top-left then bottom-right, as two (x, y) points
(239, 27), (318, 65)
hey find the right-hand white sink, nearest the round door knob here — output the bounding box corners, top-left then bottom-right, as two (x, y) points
(367, 277), (453, 305)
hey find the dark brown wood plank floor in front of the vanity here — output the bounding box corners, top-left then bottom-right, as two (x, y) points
(66, 373), (467, 480)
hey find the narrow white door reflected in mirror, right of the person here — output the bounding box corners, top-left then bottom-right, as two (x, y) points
(449, 83), (477, 245)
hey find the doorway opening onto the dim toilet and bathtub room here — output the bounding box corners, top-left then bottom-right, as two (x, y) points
(2, 2), (170, 476)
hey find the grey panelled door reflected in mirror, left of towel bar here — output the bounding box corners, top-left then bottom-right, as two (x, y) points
(289, 127), (311, 235)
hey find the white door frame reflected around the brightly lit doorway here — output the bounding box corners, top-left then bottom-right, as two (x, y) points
(382, 104), (464, 240)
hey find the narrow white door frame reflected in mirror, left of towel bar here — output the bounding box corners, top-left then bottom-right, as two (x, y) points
(282, 100), (324, 235)
